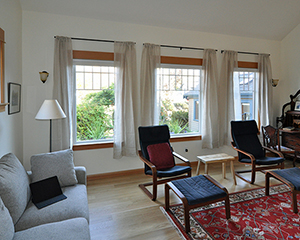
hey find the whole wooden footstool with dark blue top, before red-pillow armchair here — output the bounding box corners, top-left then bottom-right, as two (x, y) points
(165, 174), (230, 233)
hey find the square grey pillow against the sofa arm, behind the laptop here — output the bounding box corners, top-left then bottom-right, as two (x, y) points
(30, 149), (77, 187)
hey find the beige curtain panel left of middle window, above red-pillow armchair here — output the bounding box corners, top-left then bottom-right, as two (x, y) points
(140, 43), (160, 126)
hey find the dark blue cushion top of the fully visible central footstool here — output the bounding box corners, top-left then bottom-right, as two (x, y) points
(171, 175), (227, 206)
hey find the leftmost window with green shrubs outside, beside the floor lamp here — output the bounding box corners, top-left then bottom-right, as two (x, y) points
(74, 59), (115, 143)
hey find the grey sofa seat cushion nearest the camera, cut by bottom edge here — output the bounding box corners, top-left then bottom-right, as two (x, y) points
(12, 218), (90, 240)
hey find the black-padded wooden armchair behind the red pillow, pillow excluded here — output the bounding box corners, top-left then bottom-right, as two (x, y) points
(138, 125), (192, 201)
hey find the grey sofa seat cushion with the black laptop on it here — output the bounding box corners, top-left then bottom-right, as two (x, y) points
(15, 184), (89, 231)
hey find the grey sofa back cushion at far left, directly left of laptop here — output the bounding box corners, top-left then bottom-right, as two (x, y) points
(0, 153), (30, 224)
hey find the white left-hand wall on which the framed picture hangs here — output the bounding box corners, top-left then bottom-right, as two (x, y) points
(0, 0), (23, 161)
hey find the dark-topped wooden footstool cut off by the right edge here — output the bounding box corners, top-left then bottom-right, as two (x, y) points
(265, 167), (300, 213)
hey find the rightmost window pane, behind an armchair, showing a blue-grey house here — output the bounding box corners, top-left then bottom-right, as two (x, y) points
(234, 70), (257, 120)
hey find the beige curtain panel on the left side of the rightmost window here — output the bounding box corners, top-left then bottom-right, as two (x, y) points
(219, 51), (240, 146)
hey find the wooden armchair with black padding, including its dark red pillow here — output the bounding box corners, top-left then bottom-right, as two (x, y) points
(138, 125), (192, 201)
